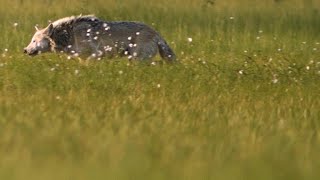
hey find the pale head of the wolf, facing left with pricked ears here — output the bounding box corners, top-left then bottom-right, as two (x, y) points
(24, 24), (54, 56)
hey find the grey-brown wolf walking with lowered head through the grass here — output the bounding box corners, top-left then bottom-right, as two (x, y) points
(24, 15), (176, 62)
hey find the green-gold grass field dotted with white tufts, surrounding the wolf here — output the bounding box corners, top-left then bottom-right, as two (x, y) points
(0, 0), (320, 180)
